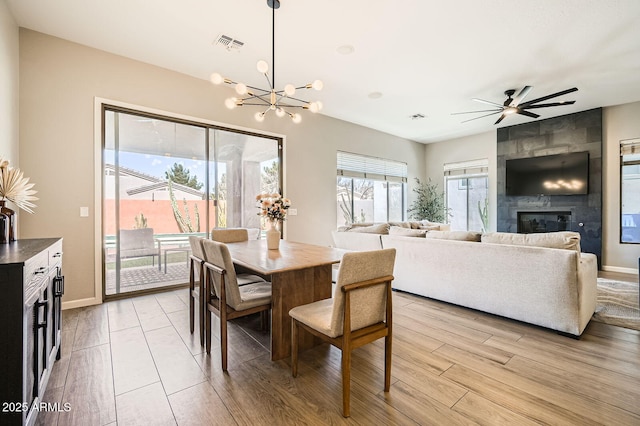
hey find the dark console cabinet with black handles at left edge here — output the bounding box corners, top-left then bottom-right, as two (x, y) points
(0, 238), (64, 425)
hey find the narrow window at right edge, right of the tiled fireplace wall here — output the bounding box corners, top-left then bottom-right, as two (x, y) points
(620, 139), (640, 244)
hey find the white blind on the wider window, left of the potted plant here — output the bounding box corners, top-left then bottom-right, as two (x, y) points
(337, 151), (407, 182)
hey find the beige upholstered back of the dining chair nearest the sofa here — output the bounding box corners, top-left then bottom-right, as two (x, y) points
(331, 249), (396, 335)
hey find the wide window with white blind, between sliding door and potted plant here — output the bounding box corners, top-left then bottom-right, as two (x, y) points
(337, 151), (407, 226)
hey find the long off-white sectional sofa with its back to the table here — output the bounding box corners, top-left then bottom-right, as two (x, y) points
(333, 225), (597, 336)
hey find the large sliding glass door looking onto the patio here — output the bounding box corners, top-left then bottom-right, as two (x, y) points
(102, 106), (282, 299)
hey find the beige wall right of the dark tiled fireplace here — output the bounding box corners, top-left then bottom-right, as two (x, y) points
(602, 102), (640, 272)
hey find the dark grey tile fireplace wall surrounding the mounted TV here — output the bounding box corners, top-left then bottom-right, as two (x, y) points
(497, 108), (602, 268)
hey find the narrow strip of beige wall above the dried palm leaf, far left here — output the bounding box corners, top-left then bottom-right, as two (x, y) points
(0, 1), (20, 167)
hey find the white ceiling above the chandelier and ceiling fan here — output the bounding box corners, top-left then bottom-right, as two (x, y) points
(6, 0), (640, 143)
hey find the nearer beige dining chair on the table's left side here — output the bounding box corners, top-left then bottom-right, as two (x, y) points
(203, 240), (271, 371)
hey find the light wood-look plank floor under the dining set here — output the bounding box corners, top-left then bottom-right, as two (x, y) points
(38, 277), (640, 426)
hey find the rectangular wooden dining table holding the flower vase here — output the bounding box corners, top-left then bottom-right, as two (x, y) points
(227, 240), (345, 361)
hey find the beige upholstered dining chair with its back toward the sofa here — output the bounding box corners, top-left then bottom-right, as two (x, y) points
(289, 249), (396, 417)
